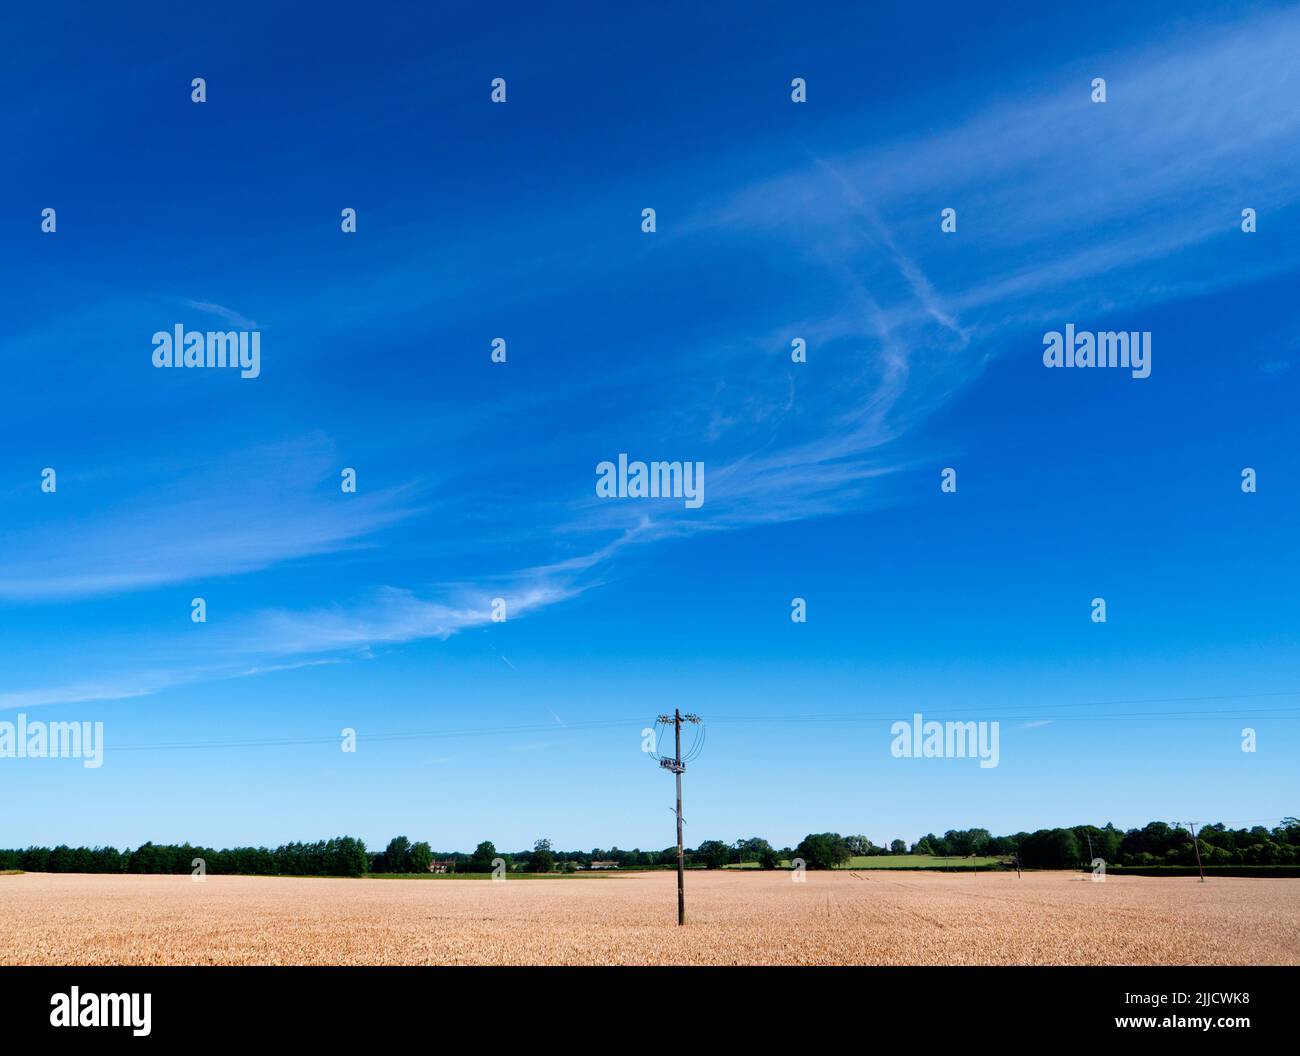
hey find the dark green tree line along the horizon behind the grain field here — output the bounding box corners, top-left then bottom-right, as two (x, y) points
(0, 818), (1300, 877)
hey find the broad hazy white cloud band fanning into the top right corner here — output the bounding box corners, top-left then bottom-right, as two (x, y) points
(696, 8), (1300, 317)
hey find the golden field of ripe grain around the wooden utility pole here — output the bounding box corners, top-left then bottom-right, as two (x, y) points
(0, 871), (1300, 965)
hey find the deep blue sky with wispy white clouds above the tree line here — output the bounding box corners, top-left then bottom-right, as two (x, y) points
(0, 4), (1300, 849)
